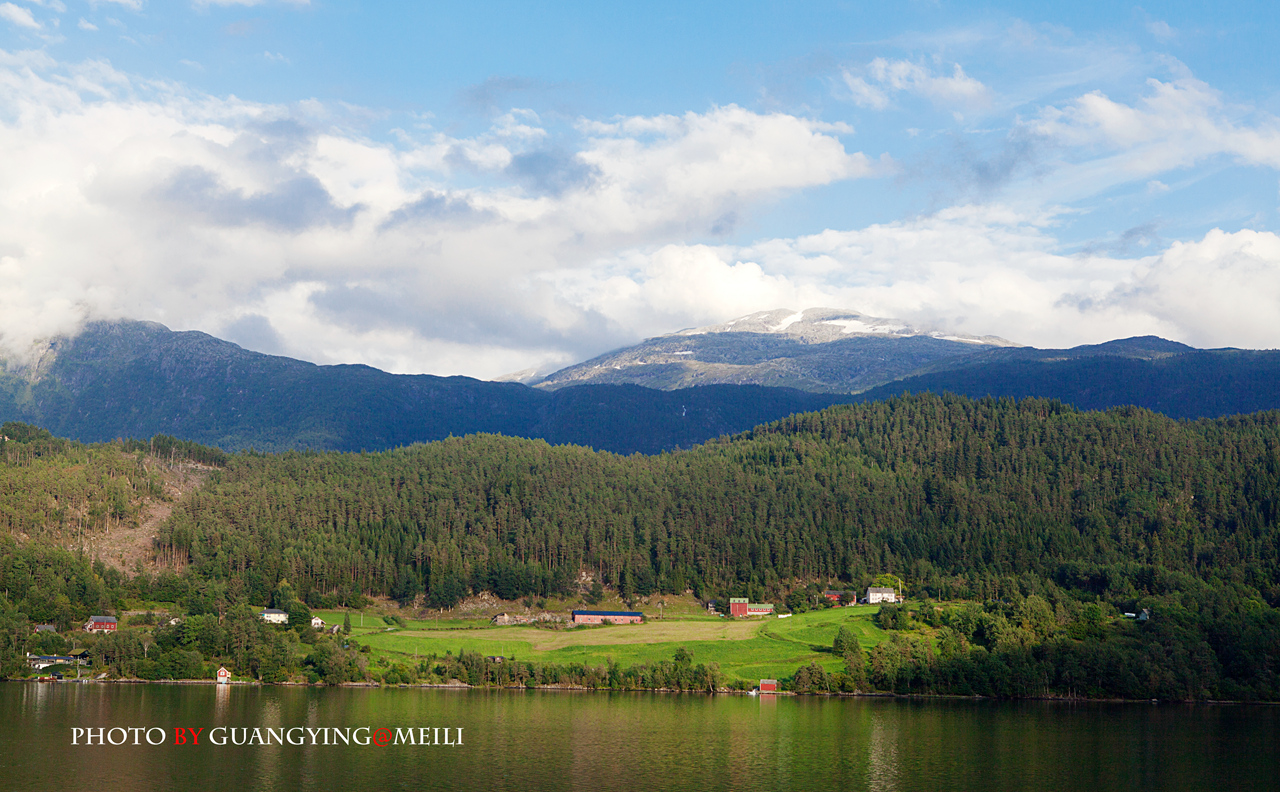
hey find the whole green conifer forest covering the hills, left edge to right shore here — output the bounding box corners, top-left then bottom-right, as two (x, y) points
(0, 395), (1280, 699)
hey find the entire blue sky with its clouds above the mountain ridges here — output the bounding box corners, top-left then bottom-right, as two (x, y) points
(0, 0), (1280, 379)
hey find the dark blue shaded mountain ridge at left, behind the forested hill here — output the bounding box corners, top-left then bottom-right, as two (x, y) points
(0, 321), (849, 453)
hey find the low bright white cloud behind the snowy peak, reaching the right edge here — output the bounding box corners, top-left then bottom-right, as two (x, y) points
(557, 205), (1280, 348)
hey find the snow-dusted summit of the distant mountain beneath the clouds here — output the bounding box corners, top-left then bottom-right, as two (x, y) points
(669, 308), (1021, 347)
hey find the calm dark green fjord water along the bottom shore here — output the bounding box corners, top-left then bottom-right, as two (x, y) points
(0, 682), (1280, 792)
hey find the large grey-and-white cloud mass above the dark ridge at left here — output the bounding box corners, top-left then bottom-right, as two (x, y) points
(0, 52), (891, 376)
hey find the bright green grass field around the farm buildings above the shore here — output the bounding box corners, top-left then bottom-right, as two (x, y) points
(330, 605), (884, 682)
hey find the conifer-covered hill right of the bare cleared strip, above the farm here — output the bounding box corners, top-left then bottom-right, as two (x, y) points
(154, 395), (1280, 604)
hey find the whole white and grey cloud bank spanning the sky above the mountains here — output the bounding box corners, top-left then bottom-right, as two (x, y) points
(0, 4), (1280, 377)
